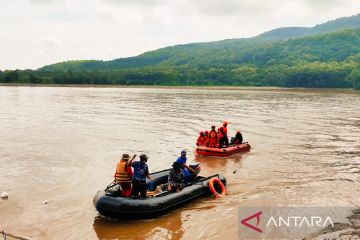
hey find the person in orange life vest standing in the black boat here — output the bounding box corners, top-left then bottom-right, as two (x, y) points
(115, 153), (136, 197)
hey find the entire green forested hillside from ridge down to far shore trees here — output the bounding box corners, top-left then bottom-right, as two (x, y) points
(0, 15), (360, 88)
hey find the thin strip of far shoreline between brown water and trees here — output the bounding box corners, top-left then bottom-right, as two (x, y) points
(0, 83), (360, 93)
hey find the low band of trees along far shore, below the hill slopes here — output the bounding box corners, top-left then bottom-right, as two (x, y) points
(0, 62), (360, 89)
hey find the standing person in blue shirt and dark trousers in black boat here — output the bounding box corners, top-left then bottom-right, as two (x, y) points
(131, 154), (152, 199)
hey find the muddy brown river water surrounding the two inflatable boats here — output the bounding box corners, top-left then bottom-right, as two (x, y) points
(0, 87), (360, 239)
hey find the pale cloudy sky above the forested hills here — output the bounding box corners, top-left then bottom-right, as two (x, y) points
(0, 0), (360, 70)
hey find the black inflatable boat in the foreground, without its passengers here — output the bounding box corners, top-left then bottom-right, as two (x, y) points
(93, 169), (226, 219)
